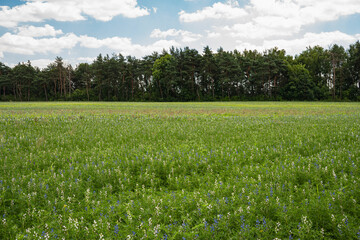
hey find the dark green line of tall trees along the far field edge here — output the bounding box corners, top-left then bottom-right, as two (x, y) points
(0, 41), (360, 101)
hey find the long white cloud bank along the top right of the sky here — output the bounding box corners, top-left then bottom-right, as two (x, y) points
(179, 0), (360, 25)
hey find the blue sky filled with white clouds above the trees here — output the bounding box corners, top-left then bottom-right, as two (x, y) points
(0, 0), (360, 68)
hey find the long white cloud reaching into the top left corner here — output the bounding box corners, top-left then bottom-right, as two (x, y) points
(0, 0), (149, 28)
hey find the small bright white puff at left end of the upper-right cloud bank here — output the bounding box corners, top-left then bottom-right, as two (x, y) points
(179, 1), (247, 23)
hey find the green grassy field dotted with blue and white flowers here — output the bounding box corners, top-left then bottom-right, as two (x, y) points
(0, 102), (360, 239)
